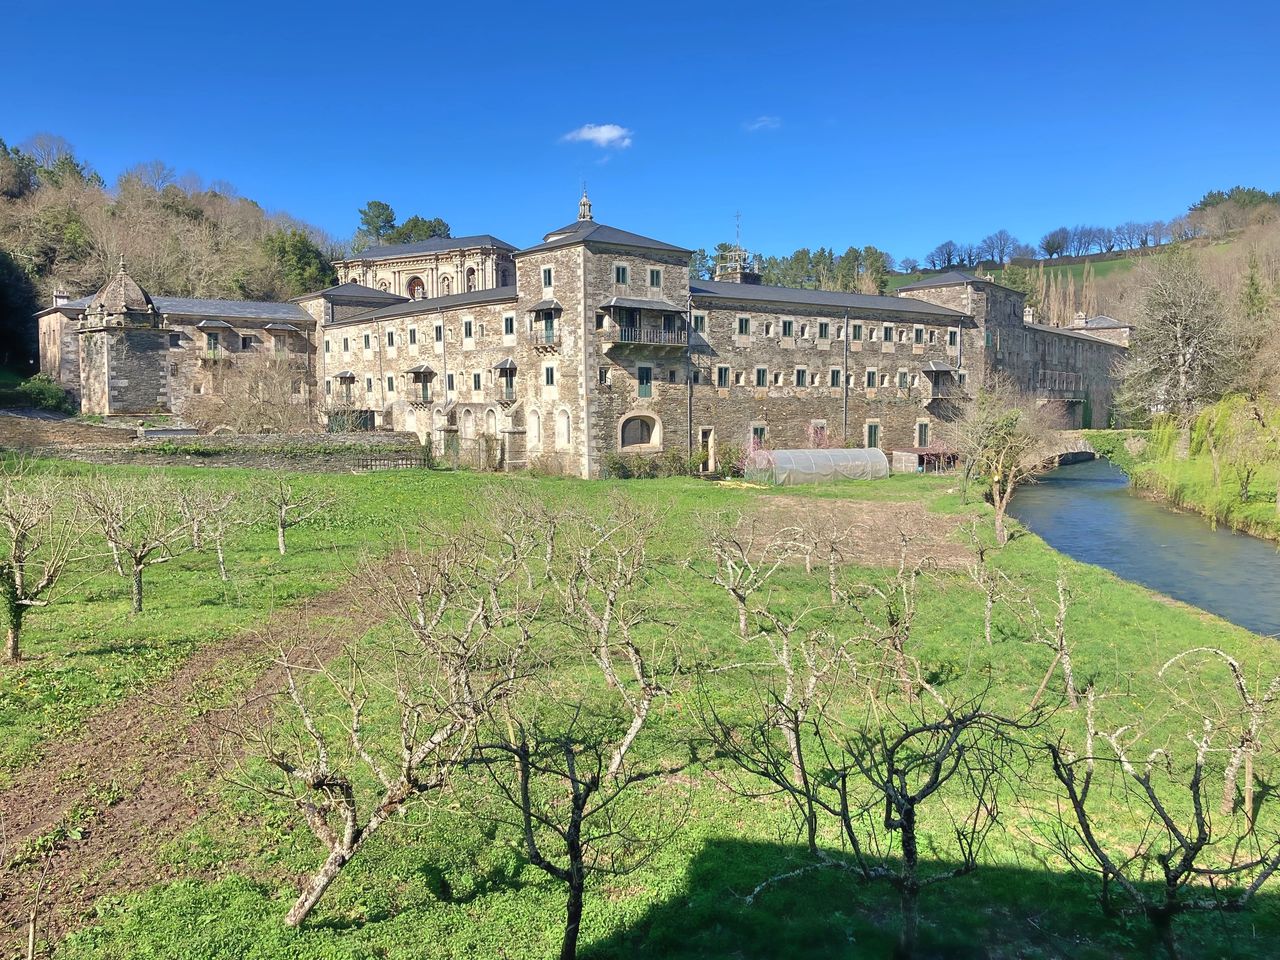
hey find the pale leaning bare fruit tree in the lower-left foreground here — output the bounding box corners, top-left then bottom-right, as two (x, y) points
(239, 522), (536, 927)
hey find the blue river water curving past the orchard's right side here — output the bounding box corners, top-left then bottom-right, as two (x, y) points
(1009, 460), (1280, 636)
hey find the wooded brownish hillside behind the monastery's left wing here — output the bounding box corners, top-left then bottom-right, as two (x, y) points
(0, 134), (334, 371)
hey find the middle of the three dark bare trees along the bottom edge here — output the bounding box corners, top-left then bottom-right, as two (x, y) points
(704, 634), (1034, 956)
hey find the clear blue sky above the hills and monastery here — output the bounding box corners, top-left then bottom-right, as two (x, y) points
(0, 0), (1280, 257)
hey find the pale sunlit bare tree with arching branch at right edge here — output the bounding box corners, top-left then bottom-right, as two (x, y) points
(1160, 646), (1280, 828)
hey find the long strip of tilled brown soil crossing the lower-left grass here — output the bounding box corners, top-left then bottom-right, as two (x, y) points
(0, 588), (369, 957)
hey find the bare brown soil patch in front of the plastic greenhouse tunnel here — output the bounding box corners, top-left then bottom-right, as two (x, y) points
(750, 497), (973, 570)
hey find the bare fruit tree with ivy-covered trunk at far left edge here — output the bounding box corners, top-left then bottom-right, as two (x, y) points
(0, 462), (84, 660)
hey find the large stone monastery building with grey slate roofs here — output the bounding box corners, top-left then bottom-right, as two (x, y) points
(40, 193), (1124, 476)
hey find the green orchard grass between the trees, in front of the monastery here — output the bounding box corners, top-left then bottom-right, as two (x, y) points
(0, 470), (1280, 960)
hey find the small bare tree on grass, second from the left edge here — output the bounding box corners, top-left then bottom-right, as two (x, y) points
(83, 476), (192, 613)
